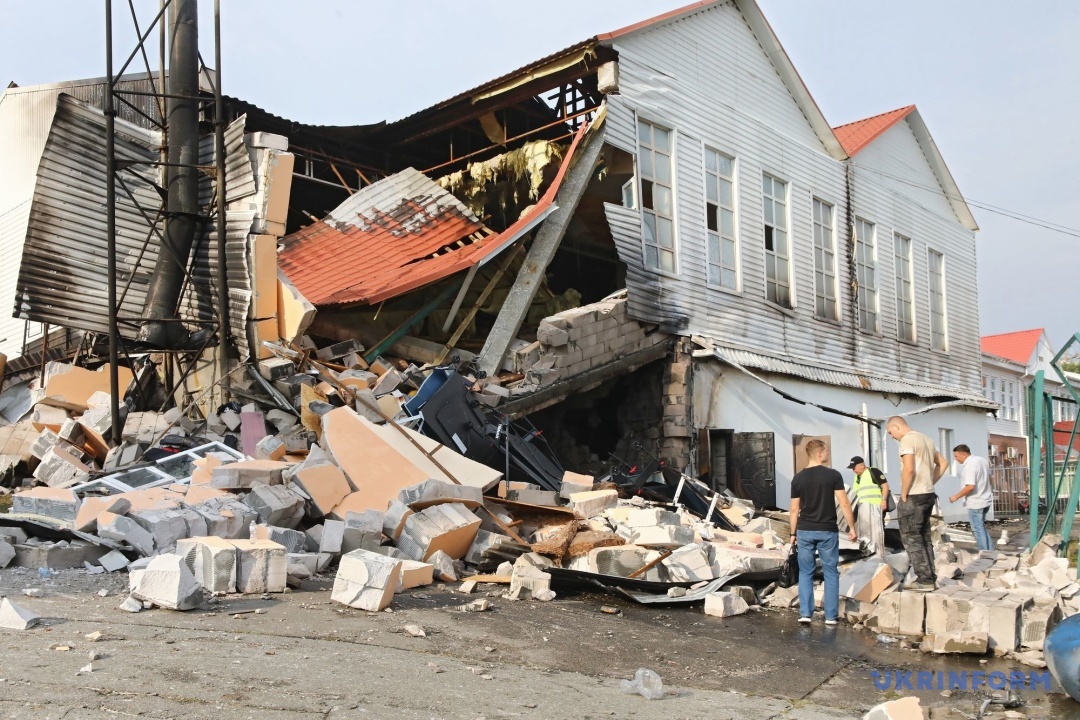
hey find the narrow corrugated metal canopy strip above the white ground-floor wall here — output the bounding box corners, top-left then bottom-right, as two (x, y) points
(712, 344), (998, 410)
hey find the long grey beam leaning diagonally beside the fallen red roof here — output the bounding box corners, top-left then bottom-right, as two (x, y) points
(478, 124), (605, 376)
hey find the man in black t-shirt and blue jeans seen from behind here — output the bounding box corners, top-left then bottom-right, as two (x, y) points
(791, 439), (859, 625)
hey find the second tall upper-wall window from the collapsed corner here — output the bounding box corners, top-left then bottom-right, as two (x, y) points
(705, 148), (739, 289)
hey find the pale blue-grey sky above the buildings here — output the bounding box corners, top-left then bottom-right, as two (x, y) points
(6, 0), (1080, 347)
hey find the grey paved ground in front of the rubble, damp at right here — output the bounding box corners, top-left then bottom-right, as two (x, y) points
(0, 569), (1071, 720)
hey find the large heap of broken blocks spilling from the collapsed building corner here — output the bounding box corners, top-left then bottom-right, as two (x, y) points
(0, 330), (786, 615)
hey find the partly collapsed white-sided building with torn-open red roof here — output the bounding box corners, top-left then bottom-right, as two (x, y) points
(0, 0), (996, 508)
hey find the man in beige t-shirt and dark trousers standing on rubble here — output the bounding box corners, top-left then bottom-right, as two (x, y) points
(886, 417), (948, 592)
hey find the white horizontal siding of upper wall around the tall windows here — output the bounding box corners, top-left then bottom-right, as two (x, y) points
(606, 3), (978, 395)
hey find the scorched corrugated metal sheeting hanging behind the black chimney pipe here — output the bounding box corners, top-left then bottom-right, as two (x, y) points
(15, 95), (254, 352)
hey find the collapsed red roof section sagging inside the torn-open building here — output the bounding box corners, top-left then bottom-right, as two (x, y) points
(278, 124), (588, 307)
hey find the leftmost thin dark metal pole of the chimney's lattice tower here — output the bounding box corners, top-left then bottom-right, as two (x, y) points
(105, 0), (123, 445)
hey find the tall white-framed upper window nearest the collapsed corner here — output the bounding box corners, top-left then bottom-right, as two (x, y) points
(637, 121), (675, 272)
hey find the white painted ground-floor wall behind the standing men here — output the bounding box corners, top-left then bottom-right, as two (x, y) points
(693, 358), (987, 508)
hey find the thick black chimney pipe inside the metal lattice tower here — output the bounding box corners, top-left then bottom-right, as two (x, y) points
(138, 0), (199, 349)
